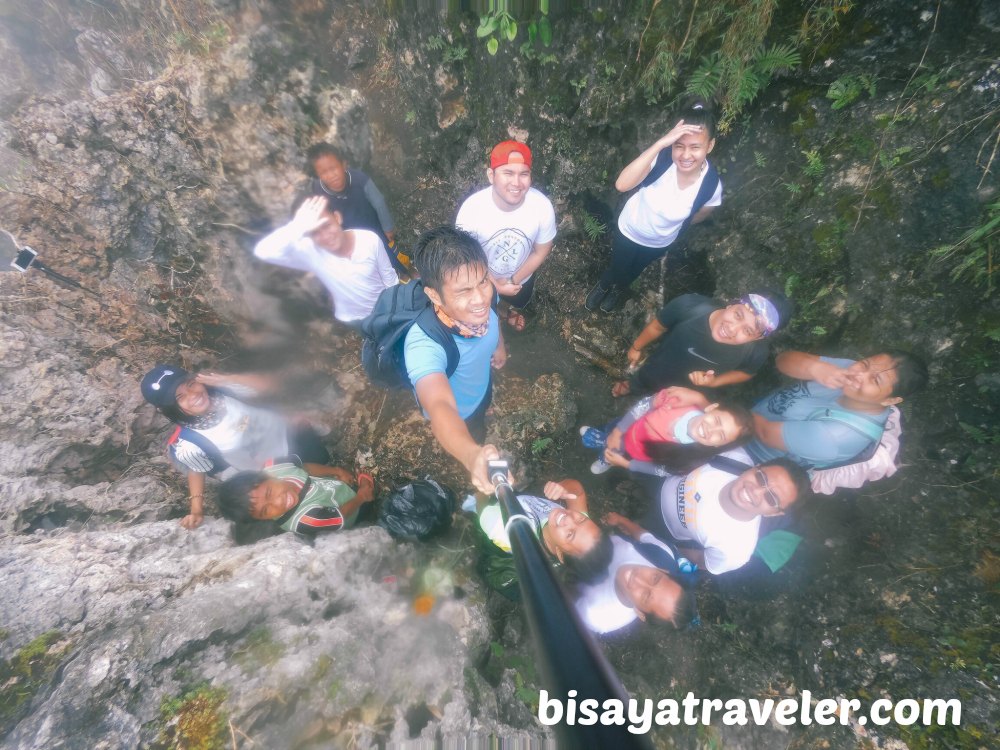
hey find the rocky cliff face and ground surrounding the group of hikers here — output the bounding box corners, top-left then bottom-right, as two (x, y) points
(0, 0), (1000, 748)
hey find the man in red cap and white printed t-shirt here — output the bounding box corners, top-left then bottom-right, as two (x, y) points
(455, 141), (556, 331)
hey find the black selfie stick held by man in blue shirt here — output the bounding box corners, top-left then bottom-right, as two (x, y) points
(489, 461), (651, 750)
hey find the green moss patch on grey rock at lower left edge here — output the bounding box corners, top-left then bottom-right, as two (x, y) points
(0, 630), (72, 736)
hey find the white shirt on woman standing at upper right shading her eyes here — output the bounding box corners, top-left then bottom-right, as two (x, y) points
(618, 157), (722, 247)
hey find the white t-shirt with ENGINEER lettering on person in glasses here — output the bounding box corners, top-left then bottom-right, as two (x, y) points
(660, 448), (760, 574)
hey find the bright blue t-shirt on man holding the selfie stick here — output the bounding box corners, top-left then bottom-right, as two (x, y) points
(403, 310), (500, 419)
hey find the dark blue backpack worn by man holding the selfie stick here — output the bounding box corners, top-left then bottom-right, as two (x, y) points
(361, 281), (459, 389)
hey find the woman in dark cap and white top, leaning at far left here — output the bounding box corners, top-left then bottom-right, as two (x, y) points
(140, 365), (330, 529)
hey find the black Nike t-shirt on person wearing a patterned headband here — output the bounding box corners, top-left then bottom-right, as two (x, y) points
(635, 294), (769, 391)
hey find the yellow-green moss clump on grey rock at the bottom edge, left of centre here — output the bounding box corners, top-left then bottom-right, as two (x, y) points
(157, 682), (229, 750)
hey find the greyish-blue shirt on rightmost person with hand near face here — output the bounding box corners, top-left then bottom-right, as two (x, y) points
(746, 357), (889, 469)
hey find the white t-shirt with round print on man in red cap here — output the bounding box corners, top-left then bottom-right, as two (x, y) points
(455, 185), (556, 283)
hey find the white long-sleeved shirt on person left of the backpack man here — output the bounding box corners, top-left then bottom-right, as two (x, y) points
(253, 222), (399, 322)
